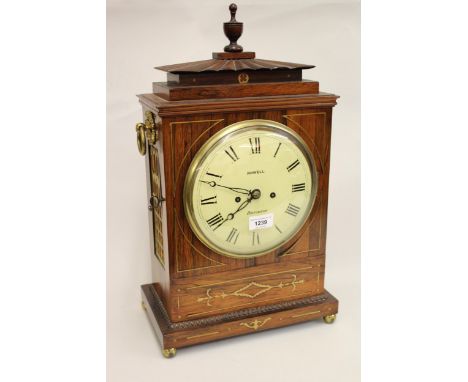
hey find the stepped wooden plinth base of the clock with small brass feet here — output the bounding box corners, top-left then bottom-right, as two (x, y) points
(141, 284), (338, 358)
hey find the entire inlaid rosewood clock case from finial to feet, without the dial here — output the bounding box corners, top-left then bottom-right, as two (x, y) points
(136, 6), (338, 357)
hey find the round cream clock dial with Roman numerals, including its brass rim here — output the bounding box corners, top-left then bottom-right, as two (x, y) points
(184, 120), (317, 257)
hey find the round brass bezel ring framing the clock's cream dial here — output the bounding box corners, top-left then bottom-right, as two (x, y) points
(183, 119), (318, 259)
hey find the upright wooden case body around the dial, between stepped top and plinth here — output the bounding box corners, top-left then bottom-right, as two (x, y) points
(140, 98), (337, 322)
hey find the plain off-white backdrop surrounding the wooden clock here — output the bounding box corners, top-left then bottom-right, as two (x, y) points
(107, 0), (360, 382)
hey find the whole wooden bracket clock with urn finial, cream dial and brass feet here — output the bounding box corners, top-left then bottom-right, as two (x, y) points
(136, 4), (338, 357)
